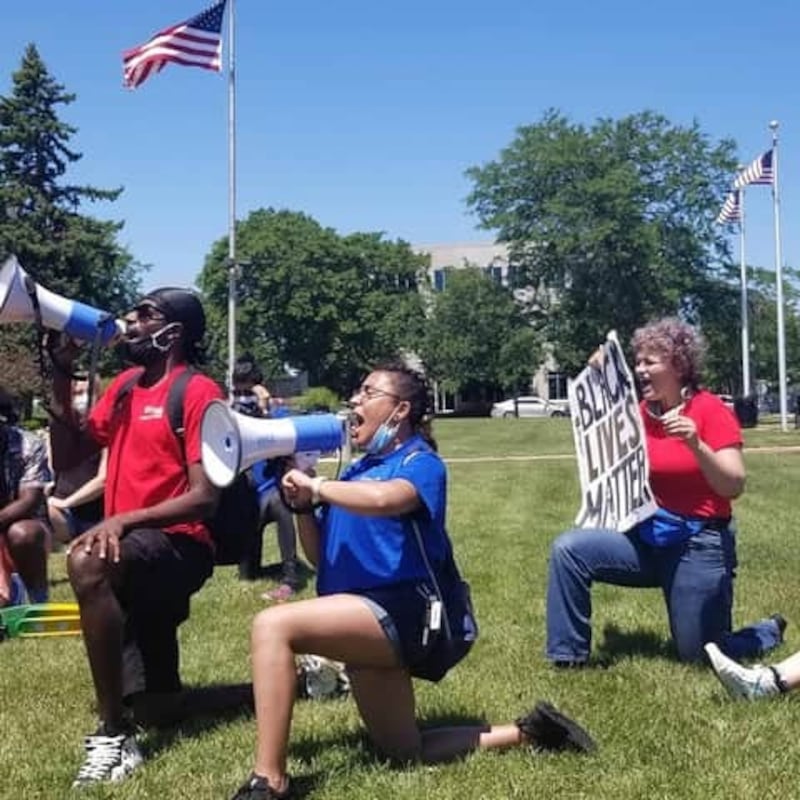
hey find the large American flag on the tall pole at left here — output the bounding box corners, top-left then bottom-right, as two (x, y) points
(122, 0), (227, 89)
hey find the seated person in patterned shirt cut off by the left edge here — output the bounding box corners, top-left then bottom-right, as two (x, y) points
(0, 388), (51, 606)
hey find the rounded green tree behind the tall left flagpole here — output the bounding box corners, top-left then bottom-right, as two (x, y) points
(199, 209), (427, 394)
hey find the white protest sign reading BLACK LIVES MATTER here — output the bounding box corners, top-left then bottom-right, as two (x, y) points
(568, 331), (658, 531)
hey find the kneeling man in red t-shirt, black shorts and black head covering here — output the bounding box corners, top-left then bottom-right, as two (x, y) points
(52, 288), (222, 786)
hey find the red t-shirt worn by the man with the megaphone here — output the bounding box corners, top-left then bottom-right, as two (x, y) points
(89, 366), (222, 544)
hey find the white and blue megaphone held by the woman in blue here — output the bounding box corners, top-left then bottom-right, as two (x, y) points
(200, 400), (345, 488)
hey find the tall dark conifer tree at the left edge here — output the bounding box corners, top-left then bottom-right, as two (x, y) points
(0, 44), (140, 393)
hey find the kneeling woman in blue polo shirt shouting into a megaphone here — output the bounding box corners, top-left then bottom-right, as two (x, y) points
(227, 363), (594, 800)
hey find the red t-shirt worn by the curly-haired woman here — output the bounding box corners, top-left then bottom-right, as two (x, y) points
(639, 391), (742, 517)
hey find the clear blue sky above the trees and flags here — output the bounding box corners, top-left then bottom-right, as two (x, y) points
(0, 0), (800, 296)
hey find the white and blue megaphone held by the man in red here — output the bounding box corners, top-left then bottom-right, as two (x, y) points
(0, 256), (125, 344)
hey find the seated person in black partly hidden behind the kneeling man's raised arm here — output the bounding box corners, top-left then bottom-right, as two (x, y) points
(47, 374), (108, 543)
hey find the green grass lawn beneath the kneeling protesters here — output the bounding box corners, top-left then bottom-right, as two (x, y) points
(0, 419), (800, 800)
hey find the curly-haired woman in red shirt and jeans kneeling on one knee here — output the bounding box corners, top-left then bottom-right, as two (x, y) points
(546, 318), (786, 666)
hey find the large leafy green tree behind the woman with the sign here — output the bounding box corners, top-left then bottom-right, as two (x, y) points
(467, 111), (736, 371)
